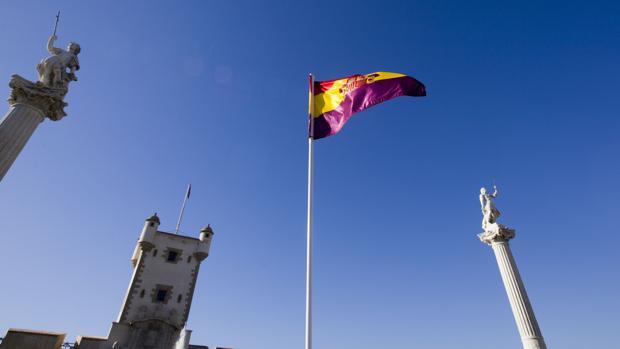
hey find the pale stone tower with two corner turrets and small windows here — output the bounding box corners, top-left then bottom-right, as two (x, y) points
(104, 214), (213, 349)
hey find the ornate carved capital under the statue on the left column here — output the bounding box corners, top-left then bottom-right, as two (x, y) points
(8, 74), (68, 121)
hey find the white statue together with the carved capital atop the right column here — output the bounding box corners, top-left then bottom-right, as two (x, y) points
(478, 184), (515, 244)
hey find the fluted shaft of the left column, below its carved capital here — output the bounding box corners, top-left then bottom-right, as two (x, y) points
(0, 103), (45, 181)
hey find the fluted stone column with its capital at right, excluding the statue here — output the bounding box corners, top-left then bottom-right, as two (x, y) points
(478, 227), (547, 349)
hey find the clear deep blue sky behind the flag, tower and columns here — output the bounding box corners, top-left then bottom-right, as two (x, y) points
(0, 0), (620, 349)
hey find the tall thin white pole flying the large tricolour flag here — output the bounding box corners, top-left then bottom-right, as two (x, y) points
(306, 74), (314, 349)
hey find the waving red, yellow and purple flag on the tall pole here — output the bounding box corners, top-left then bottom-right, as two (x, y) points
(310, 72), (426, 139)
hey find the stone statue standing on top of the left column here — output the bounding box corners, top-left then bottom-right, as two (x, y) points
(37, 35), (80, 88)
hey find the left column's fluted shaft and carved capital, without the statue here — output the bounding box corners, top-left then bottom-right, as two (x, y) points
(0, 75), (67, 181)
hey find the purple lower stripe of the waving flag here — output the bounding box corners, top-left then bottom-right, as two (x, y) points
(313, 76), (426, 139)
